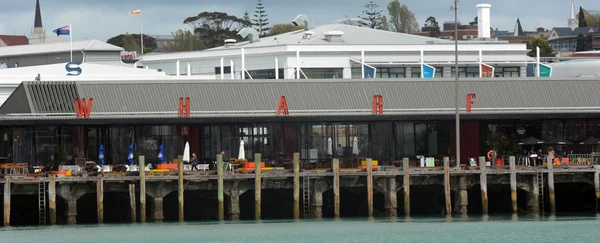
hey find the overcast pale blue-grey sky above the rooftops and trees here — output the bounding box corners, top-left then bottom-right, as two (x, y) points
(0, 0), (600, 41)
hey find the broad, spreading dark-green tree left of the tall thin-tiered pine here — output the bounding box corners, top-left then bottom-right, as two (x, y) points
(183, 12), (249, 48)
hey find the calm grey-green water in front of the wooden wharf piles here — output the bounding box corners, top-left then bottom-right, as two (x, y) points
(0, 216), (600, 243)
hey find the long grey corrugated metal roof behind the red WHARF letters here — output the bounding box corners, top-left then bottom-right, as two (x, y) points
(0, 78), (600, 118)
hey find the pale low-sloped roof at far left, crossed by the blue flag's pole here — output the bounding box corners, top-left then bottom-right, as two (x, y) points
(0, 40), (124, 57)
